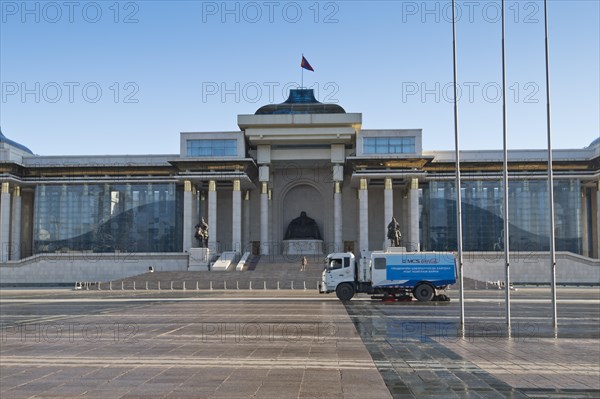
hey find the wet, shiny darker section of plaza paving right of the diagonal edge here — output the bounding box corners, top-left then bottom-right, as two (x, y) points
(346, 292), (600, 399)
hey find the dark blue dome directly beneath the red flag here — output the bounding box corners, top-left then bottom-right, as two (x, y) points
(254, 89), (346, 115)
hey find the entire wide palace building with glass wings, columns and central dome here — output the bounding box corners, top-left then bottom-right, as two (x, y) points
(0, 89), (600, 285)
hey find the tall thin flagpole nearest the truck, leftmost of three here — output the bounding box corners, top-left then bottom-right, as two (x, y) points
(452, 0), (465, 326)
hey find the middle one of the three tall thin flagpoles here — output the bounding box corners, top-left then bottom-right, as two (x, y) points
(502, 0), (510, 328)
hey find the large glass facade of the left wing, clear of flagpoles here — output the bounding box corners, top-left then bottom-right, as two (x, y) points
(33, 183), (183, 253)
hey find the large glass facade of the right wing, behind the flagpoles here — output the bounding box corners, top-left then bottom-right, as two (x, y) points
(421, 180), (582, 254)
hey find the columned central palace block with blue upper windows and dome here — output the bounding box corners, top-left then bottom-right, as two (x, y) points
(172, 89), (424, 259)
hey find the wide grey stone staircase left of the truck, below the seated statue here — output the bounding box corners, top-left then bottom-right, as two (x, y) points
(108, 255), (324, 291)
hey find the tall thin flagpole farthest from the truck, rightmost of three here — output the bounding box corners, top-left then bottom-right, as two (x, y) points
(544, 0), (558, 328)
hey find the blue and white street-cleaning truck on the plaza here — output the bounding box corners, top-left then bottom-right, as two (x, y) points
(319, 249), (456, 302)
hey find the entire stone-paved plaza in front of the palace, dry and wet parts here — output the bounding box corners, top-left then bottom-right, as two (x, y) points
(0, 288), (600, 399)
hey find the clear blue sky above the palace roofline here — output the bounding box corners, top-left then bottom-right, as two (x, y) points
(0, 0), (600, 155)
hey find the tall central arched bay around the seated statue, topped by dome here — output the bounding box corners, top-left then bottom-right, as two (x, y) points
(238, 89), (362, 254)
